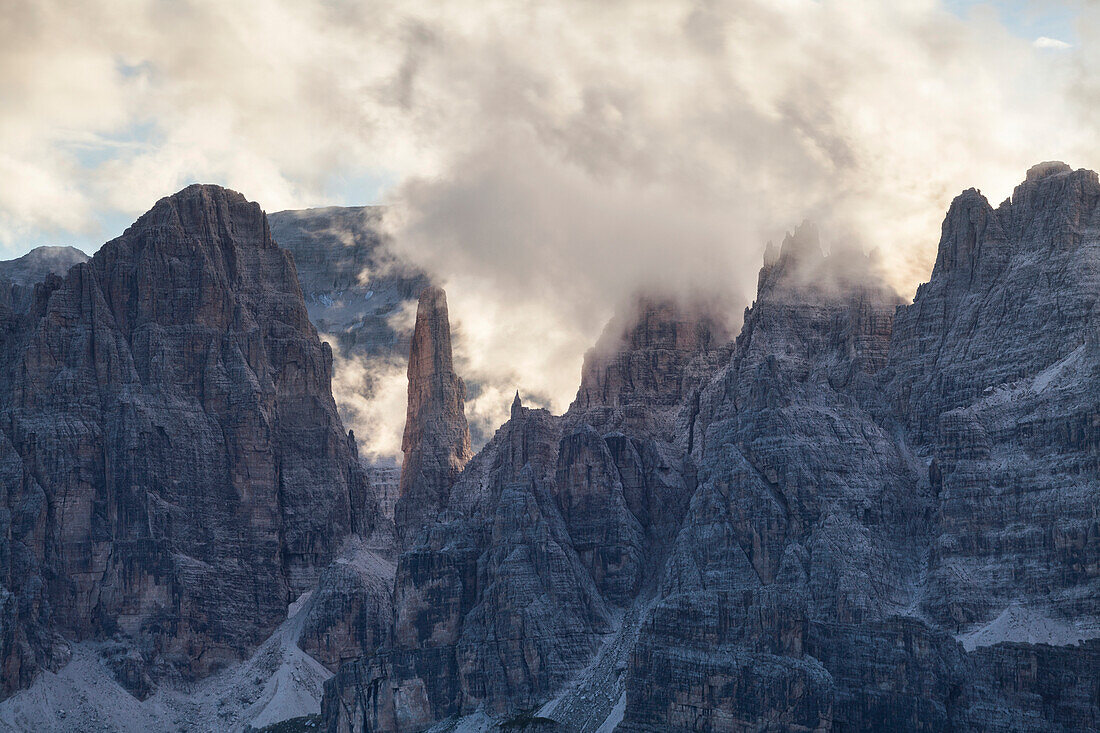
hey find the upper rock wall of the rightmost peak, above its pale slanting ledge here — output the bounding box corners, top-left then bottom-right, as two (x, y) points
(890, 163), (1100, 442)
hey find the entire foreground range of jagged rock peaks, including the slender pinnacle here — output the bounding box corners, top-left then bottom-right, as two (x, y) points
(0, 163), (1100, 733)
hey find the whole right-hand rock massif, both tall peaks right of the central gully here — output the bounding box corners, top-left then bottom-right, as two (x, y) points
(618, 172), (1100, 731)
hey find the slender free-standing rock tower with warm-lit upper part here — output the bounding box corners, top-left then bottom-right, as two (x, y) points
(394, 286), (472, 540)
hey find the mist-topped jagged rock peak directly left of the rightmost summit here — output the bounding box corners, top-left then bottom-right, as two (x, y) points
(619, 227), (933, 731)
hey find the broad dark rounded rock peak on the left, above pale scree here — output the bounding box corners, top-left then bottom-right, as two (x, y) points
(0, 185), (378, 692)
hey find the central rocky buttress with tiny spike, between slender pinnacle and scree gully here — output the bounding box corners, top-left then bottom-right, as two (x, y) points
(325, 294), (719, 731)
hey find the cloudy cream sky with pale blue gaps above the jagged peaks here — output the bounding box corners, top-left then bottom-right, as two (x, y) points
(0, 0), (1100, 451)
